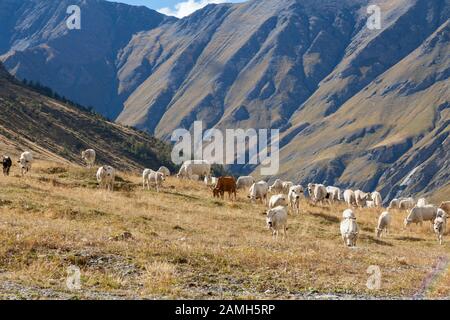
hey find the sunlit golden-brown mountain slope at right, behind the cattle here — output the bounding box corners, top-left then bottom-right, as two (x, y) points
(272, 21), (450, 198)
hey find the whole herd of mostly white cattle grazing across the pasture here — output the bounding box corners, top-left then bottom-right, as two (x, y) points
(3, 149), (450, 247)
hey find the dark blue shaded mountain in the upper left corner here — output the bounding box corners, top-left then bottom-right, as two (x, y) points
(0, 0), (172, 119)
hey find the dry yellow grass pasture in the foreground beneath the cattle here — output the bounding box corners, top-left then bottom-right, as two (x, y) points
(0, 162), (450, 299)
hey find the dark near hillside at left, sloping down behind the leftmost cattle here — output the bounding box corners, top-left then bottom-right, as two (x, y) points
(0, 65), (172, 172)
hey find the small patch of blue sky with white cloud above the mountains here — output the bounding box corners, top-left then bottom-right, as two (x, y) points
(109, 0), (244, 18)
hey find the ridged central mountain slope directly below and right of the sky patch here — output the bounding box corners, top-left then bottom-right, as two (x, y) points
(118, 0), (367, 137)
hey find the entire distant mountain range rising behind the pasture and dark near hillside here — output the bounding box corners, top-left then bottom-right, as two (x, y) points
(0, 0), (450, 198)
